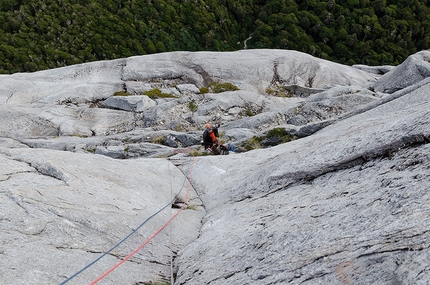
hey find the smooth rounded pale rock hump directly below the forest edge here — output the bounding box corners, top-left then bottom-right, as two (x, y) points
(122, 50), (375, 93)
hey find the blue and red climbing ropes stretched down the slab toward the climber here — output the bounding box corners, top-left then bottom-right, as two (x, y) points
(59, 156), (194, 285)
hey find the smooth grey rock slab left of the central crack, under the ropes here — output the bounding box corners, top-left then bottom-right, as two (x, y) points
(0, 148), (203, 284)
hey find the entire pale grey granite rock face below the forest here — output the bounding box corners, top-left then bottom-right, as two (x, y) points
(0, 50), (430, 285)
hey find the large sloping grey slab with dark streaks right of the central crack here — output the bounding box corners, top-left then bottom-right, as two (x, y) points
(175, 80), (430, 284)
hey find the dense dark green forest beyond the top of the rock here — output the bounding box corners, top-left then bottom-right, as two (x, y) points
(0, 0), (430, 74)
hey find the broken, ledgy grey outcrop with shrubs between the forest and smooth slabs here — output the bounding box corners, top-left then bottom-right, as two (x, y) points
(0, 50), (378, 155)
